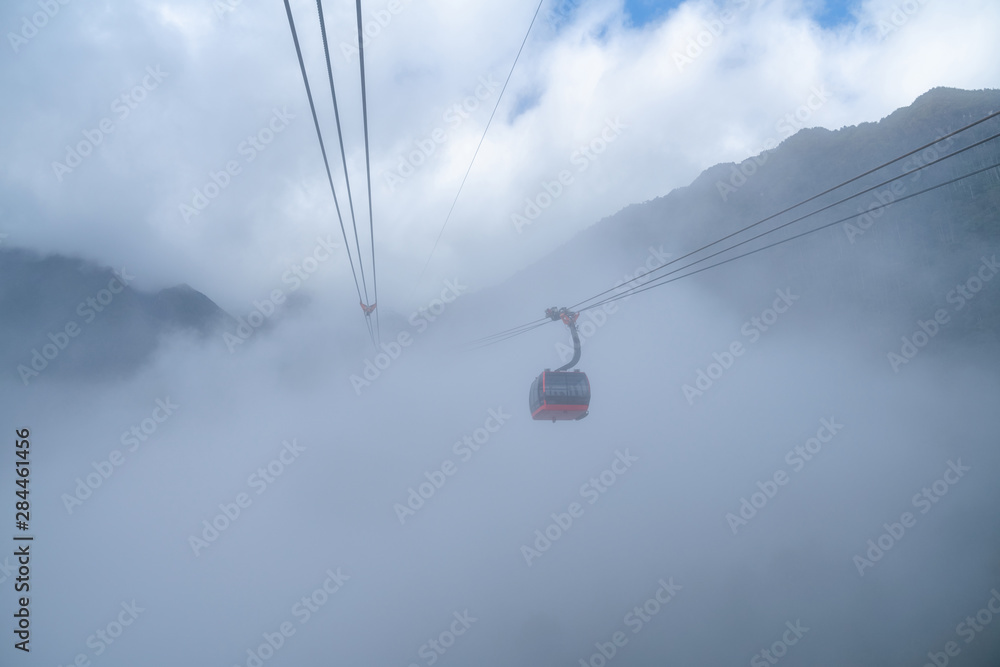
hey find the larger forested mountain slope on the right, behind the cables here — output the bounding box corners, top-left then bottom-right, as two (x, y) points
(485, 88), (1000, 339)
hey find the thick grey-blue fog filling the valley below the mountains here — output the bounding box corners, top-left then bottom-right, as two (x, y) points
(4, 190), (1000, 665)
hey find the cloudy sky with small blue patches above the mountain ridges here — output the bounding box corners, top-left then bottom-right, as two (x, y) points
(0, 0), (1000, 312)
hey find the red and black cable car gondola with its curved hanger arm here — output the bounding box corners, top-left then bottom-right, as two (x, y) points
(528, 308), (590, 423)
